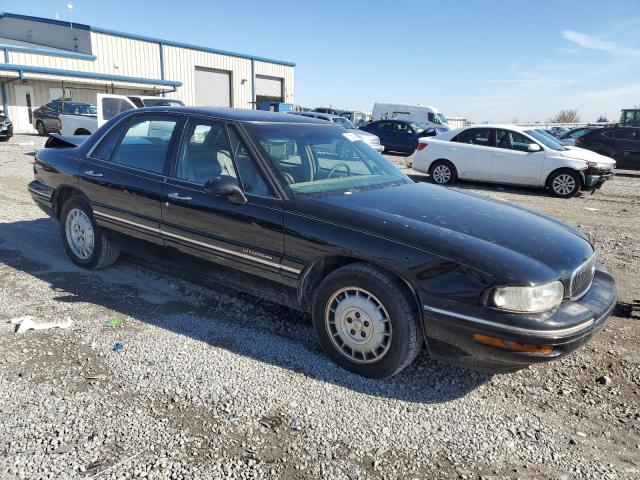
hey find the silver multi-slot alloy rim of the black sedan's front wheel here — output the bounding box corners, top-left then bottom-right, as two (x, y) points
(325, 287), (392, 364)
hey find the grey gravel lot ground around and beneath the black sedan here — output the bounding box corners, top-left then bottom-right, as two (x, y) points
(0, 135), (640, 480)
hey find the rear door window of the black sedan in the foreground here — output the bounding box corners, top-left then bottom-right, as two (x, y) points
(111, 115), (177, 173)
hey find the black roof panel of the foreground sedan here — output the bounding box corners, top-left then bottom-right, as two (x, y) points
(128, 107), (327, 125)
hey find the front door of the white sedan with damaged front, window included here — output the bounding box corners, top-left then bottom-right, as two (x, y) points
(491, 129), (545, 185)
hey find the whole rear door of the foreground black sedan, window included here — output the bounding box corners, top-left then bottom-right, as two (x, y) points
(80, 113), (183, 244)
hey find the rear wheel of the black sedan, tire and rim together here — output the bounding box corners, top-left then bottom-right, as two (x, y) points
(60, 196), (120, 270)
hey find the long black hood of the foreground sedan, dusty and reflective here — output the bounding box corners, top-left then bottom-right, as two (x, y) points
(316, 183), (593, 285)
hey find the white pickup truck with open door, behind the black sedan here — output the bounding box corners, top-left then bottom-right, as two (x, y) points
(58, 94), (184, 135)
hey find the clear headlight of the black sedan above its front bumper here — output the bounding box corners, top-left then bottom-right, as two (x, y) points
(490, 281), (564, 313)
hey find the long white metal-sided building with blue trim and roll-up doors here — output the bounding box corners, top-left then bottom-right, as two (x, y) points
(0, 13), (295, 132)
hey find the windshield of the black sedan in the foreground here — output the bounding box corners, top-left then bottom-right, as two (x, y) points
(245, 123), (411, 197)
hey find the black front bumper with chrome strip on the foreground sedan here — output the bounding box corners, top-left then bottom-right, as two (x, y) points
(423, 264), (617, 372)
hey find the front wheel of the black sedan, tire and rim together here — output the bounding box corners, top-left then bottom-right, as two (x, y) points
(312, 263), (422, 378)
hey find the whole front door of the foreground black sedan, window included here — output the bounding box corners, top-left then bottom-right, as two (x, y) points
(162, 118), (284, 286)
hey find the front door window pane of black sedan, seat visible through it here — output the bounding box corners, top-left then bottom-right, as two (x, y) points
(176, 121), (237, 185)
